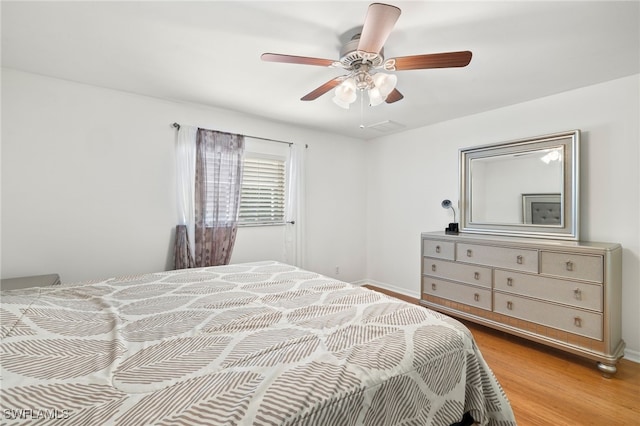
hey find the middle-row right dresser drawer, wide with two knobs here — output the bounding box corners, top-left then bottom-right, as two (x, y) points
(494, 269), (603, 312)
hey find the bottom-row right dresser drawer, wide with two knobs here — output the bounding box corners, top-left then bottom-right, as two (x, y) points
(494, 292), (602, 340)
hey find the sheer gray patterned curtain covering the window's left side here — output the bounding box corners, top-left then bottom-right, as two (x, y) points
(193, 129), (244, 266)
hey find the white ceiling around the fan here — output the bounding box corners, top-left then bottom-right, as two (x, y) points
(1, 0), (640, 139)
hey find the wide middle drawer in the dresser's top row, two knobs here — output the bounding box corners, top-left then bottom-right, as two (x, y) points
(456, 243), (538, 273)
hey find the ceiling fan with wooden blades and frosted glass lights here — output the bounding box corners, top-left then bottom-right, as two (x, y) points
(261, 3), (472, 108)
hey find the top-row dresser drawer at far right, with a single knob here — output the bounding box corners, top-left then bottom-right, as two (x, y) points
(540, 251), (604, 283)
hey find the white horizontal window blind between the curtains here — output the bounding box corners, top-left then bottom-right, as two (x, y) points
(239, 156), (286, 225)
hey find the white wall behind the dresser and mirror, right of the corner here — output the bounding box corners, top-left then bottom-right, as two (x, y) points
(367, 75), (640, 360)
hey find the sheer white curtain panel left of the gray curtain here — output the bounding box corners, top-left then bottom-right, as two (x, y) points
(175, 125), (198, 268)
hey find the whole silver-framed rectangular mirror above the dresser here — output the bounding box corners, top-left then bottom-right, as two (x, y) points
(460, 130), (580, 240)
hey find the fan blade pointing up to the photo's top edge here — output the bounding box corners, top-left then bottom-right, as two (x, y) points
(358, 3), (400, 53)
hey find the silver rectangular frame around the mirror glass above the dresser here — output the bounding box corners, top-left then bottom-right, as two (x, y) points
(460, 130), (580, 240)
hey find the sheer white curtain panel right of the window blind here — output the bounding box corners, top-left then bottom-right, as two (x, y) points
(284, 144), (306, 268)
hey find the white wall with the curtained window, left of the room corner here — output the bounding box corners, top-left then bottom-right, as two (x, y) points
(0, 69), (366, 282)
